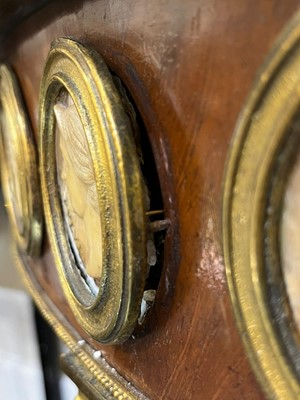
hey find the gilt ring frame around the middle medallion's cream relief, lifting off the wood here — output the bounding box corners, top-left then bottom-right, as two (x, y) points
(40, 38), (147, 343)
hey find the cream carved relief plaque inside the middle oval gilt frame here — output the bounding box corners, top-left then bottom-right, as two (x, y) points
(54, 94), (102, 294)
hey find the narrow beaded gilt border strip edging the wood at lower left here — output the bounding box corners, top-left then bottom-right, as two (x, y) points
(14, 251), (147, 400)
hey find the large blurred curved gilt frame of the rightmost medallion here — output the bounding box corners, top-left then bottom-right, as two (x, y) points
(223, 9), (300, 400)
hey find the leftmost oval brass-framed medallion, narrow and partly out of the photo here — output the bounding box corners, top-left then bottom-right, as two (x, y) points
(0, 65), (43, 256)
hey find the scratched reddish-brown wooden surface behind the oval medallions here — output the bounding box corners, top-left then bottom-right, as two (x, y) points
(1, 0), (299, 400)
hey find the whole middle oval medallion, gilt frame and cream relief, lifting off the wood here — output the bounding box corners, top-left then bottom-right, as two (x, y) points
(40, 39), (147, 343)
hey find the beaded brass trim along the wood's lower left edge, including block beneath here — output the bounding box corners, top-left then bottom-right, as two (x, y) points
(15, 252), (147, 400)
